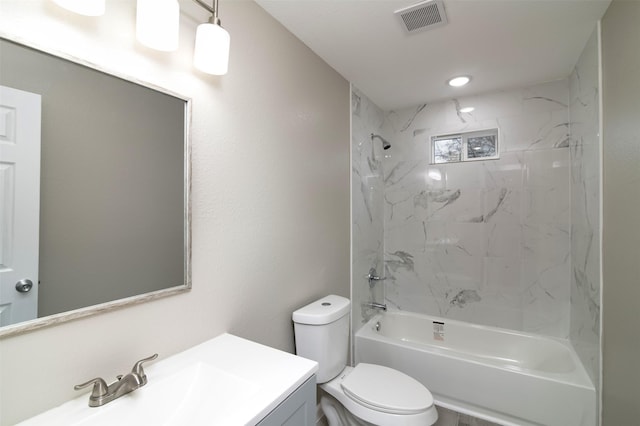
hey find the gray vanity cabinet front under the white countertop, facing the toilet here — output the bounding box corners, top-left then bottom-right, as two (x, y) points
(258, 375), (316, 426)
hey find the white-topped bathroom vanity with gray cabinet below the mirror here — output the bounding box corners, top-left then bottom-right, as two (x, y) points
(20, 334), (318, 426)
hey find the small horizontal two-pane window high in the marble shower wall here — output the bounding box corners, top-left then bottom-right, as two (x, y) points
(431, 129), (499, 164)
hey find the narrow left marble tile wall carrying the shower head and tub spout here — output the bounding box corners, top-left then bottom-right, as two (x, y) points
(351, 86), (384, 333)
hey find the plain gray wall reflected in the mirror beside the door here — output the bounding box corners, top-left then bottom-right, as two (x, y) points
(0, 41), (185, 317)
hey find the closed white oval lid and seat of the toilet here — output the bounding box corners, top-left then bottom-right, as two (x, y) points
(341, 363), (433, 415)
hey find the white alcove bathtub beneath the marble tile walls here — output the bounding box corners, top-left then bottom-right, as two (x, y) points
(355, 311), (596, 426)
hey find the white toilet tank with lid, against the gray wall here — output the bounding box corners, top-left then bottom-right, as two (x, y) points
(293, 295), (351, 383)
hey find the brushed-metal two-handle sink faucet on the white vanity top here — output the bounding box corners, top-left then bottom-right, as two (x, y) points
(73, 354), (158, 407)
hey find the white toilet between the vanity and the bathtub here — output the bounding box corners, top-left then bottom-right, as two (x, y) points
(293, 295), (438, 426)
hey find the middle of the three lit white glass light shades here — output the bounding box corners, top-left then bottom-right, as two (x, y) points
(136, 0), (180, 52)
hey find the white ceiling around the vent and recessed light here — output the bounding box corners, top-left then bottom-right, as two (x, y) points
(257, 0), (610, 110)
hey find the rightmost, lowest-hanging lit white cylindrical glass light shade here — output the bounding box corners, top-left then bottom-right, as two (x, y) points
(193, 23), (231, 75)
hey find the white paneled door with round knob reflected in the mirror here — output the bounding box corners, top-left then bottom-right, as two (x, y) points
(0, 86), (41, 326)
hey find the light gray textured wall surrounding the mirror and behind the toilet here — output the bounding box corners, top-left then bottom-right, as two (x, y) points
(0, 0), (350, 425)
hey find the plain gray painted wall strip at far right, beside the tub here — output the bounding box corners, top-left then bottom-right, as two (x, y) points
(602, 0), (640, 426)
